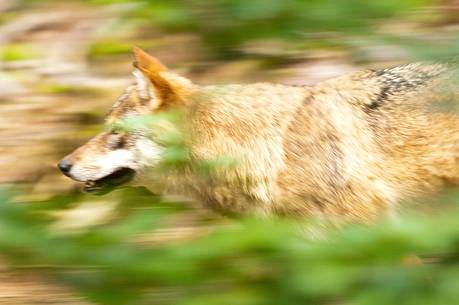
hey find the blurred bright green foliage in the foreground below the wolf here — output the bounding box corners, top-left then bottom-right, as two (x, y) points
(0, 185), (459, 305)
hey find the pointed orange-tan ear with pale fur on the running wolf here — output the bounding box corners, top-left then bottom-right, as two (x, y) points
(132, 47), (192, 109)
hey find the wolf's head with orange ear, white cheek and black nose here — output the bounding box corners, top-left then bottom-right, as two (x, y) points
(58, 47), (193, 194)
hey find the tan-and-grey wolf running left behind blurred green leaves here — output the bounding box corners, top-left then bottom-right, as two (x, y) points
(58, 47), (459, 222)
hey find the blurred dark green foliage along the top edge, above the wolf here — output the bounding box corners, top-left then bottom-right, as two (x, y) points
(95, 0), (432, 57)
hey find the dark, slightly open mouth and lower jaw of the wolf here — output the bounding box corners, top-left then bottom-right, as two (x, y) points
(84, 167), (135, 195)
